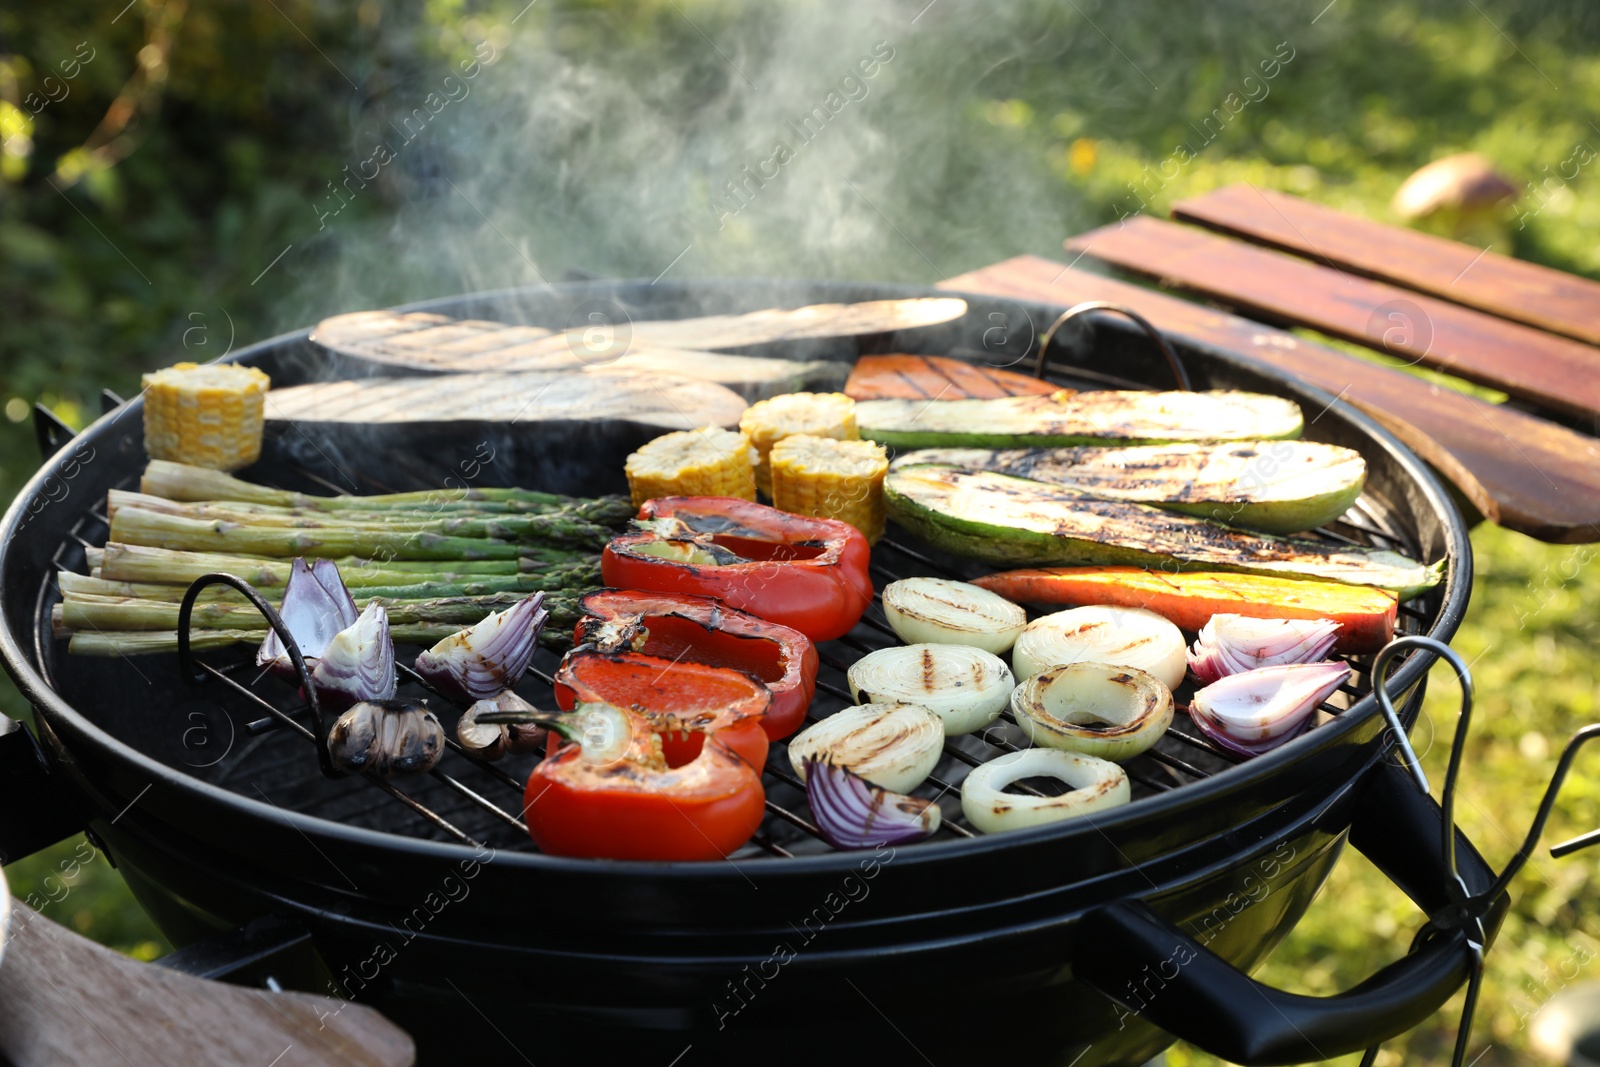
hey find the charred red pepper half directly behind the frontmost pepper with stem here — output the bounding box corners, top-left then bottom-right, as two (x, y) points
(555, 648), (773, 774)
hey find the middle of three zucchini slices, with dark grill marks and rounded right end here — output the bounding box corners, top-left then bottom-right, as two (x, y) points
(894, 440), (1366, 533)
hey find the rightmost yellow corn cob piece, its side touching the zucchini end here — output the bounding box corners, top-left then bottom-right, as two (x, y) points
(771, 434), (890, 542)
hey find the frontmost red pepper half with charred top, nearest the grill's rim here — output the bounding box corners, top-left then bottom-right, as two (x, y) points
(523, 704), (766, 861)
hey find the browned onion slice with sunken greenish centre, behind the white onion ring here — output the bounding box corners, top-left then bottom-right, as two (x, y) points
(1011, 664), (1173, 760)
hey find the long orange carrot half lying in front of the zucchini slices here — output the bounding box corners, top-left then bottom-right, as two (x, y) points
(973, 566), (1397, 653)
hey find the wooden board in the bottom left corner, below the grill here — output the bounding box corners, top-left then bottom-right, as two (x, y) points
(0, 901), (416, 1067)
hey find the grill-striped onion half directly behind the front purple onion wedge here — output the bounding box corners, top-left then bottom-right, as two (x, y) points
(789, 704), (944, 793)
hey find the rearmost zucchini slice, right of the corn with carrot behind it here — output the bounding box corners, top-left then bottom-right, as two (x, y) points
(856, 390), (1304, 448)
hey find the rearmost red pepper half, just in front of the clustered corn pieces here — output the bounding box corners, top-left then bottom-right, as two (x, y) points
(600, 496), (872, 641)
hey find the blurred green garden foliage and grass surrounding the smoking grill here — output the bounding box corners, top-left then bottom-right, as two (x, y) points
(0, 0), (1600, 1067)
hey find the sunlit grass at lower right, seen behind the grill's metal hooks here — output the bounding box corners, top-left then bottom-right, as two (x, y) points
(1168, 526), (1600, 1067)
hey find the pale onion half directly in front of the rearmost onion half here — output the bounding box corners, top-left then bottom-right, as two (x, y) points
(846, 645), (1016, 736)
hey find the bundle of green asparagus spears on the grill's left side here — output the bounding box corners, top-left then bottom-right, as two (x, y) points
(53, 461), (620, 656)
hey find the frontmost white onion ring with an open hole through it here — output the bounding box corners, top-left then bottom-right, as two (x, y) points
(962, 749), (1133, 833)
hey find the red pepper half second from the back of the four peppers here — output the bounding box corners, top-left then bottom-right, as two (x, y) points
(573, 589), (818, 741)
